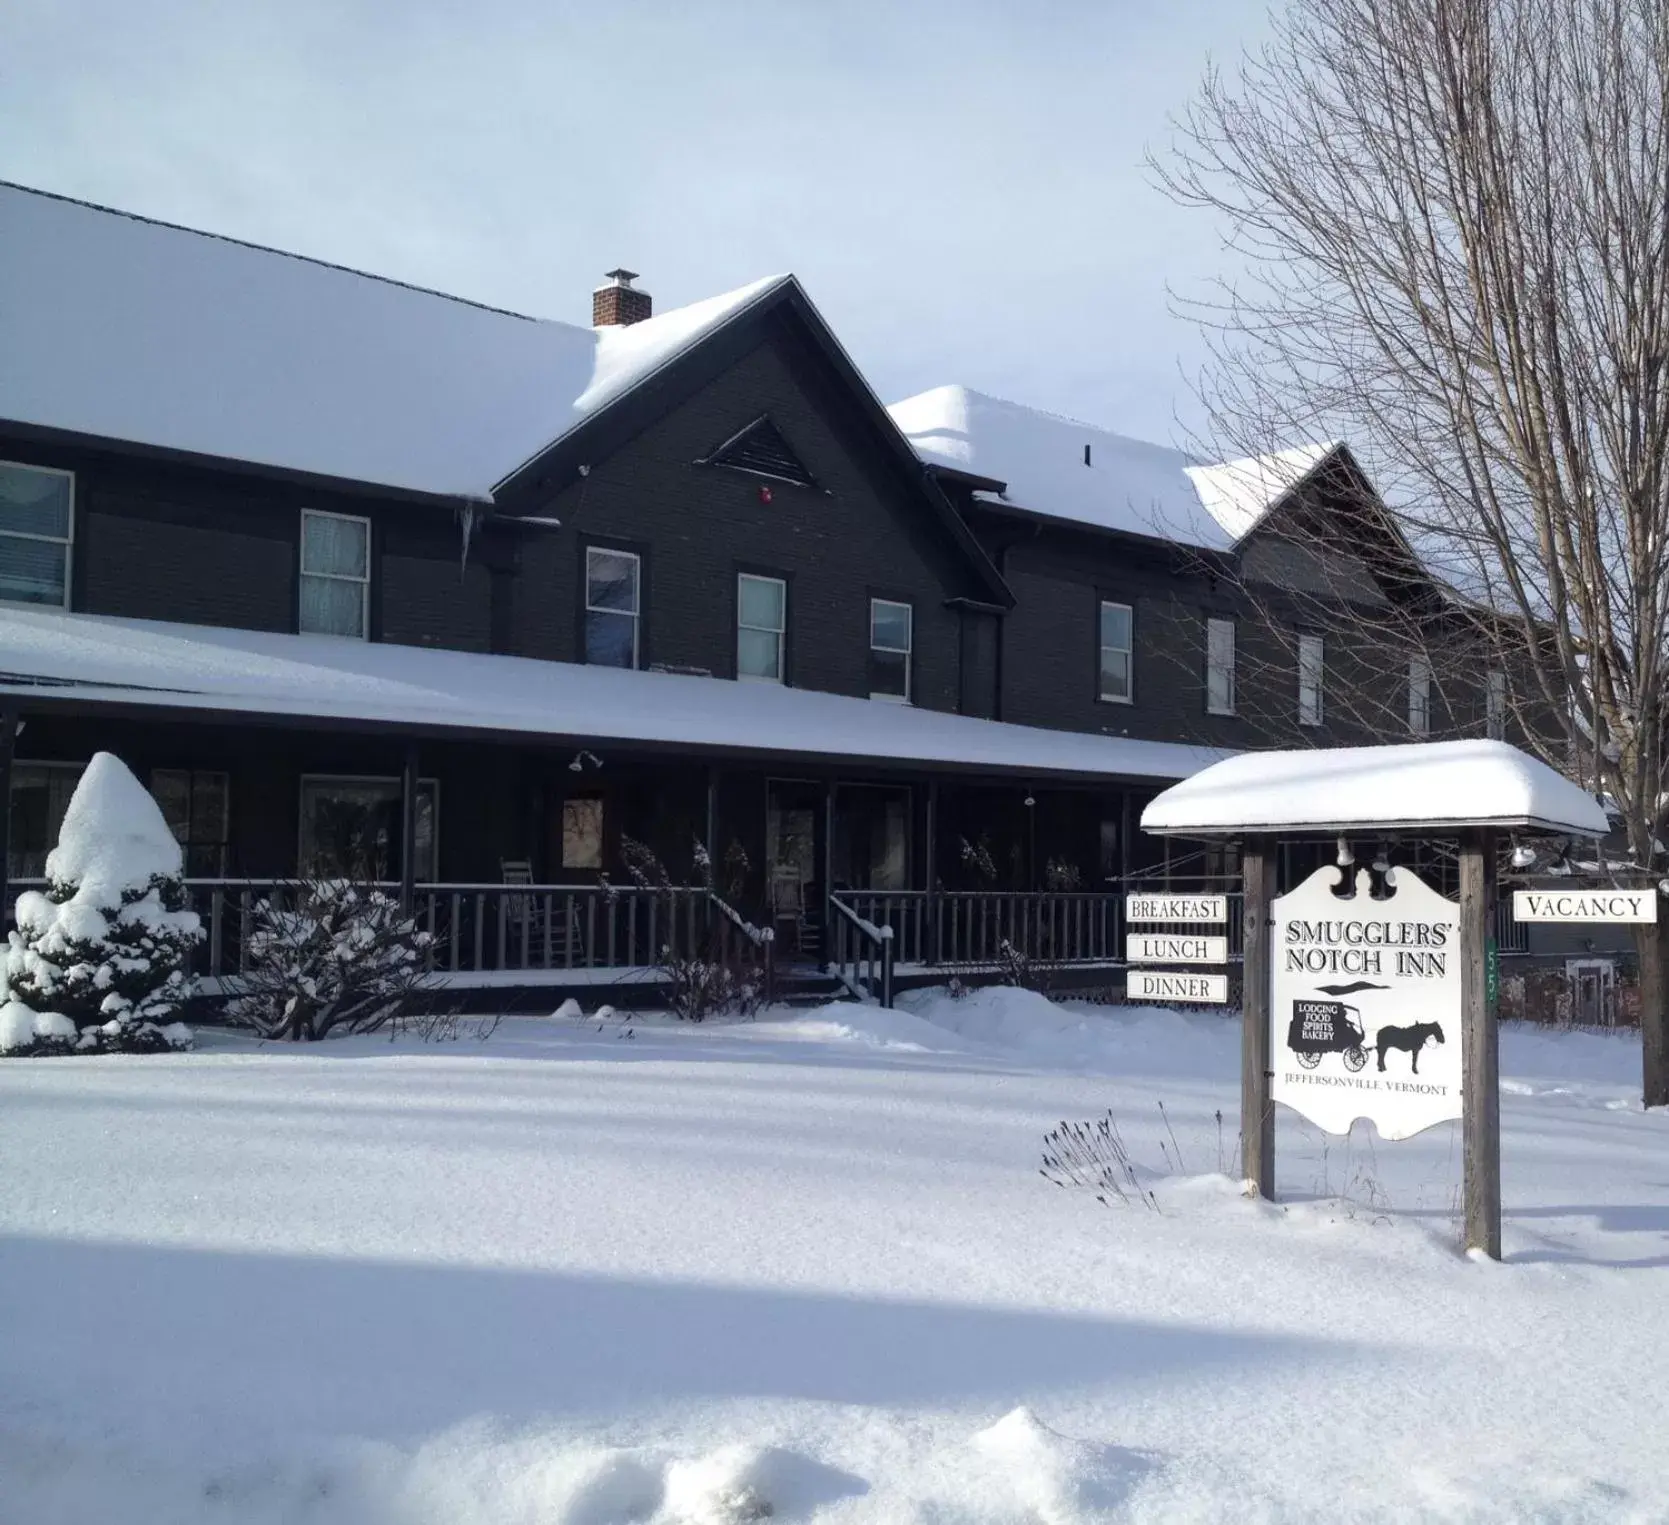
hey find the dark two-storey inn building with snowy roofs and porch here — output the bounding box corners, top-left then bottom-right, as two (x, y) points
(0, 187), (1575, 989)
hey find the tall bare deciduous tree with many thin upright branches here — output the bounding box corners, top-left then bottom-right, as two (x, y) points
(1157, 0), (1669, 1106)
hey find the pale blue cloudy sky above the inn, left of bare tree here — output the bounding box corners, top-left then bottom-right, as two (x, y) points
(0, 0), (1263, 442)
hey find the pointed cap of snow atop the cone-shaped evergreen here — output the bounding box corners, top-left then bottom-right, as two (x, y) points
(47, 752), (180, 906)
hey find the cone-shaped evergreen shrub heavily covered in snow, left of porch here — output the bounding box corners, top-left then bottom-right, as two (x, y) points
(0, 752), (202, 1054)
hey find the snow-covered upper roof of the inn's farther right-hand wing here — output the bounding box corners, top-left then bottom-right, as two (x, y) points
(888, 385), (1337, 551)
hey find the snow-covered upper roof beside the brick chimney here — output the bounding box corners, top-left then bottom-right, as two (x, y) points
(0, 182), (793, 497)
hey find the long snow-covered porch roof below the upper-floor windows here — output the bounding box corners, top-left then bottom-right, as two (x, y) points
(0, 609), (1228, 779)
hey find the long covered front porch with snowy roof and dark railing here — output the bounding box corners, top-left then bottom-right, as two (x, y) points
(0, 600), (1237, 998)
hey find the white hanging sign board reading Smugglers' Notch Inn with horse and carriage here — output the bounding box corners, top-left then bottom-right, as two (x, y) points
(1270, 868), (1462, 1138)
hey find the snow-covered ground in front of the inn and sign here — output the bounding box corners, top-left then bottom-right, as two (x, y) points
(0, 991), (1669, 1525)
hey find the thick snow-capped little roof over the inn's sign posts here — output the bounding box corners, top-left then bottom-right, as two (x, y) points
(1142, 741), (1609, 836)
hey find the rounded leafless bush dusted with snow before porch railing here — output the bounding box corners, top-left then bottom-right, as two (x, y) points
(227, 879), (434, 1043)
